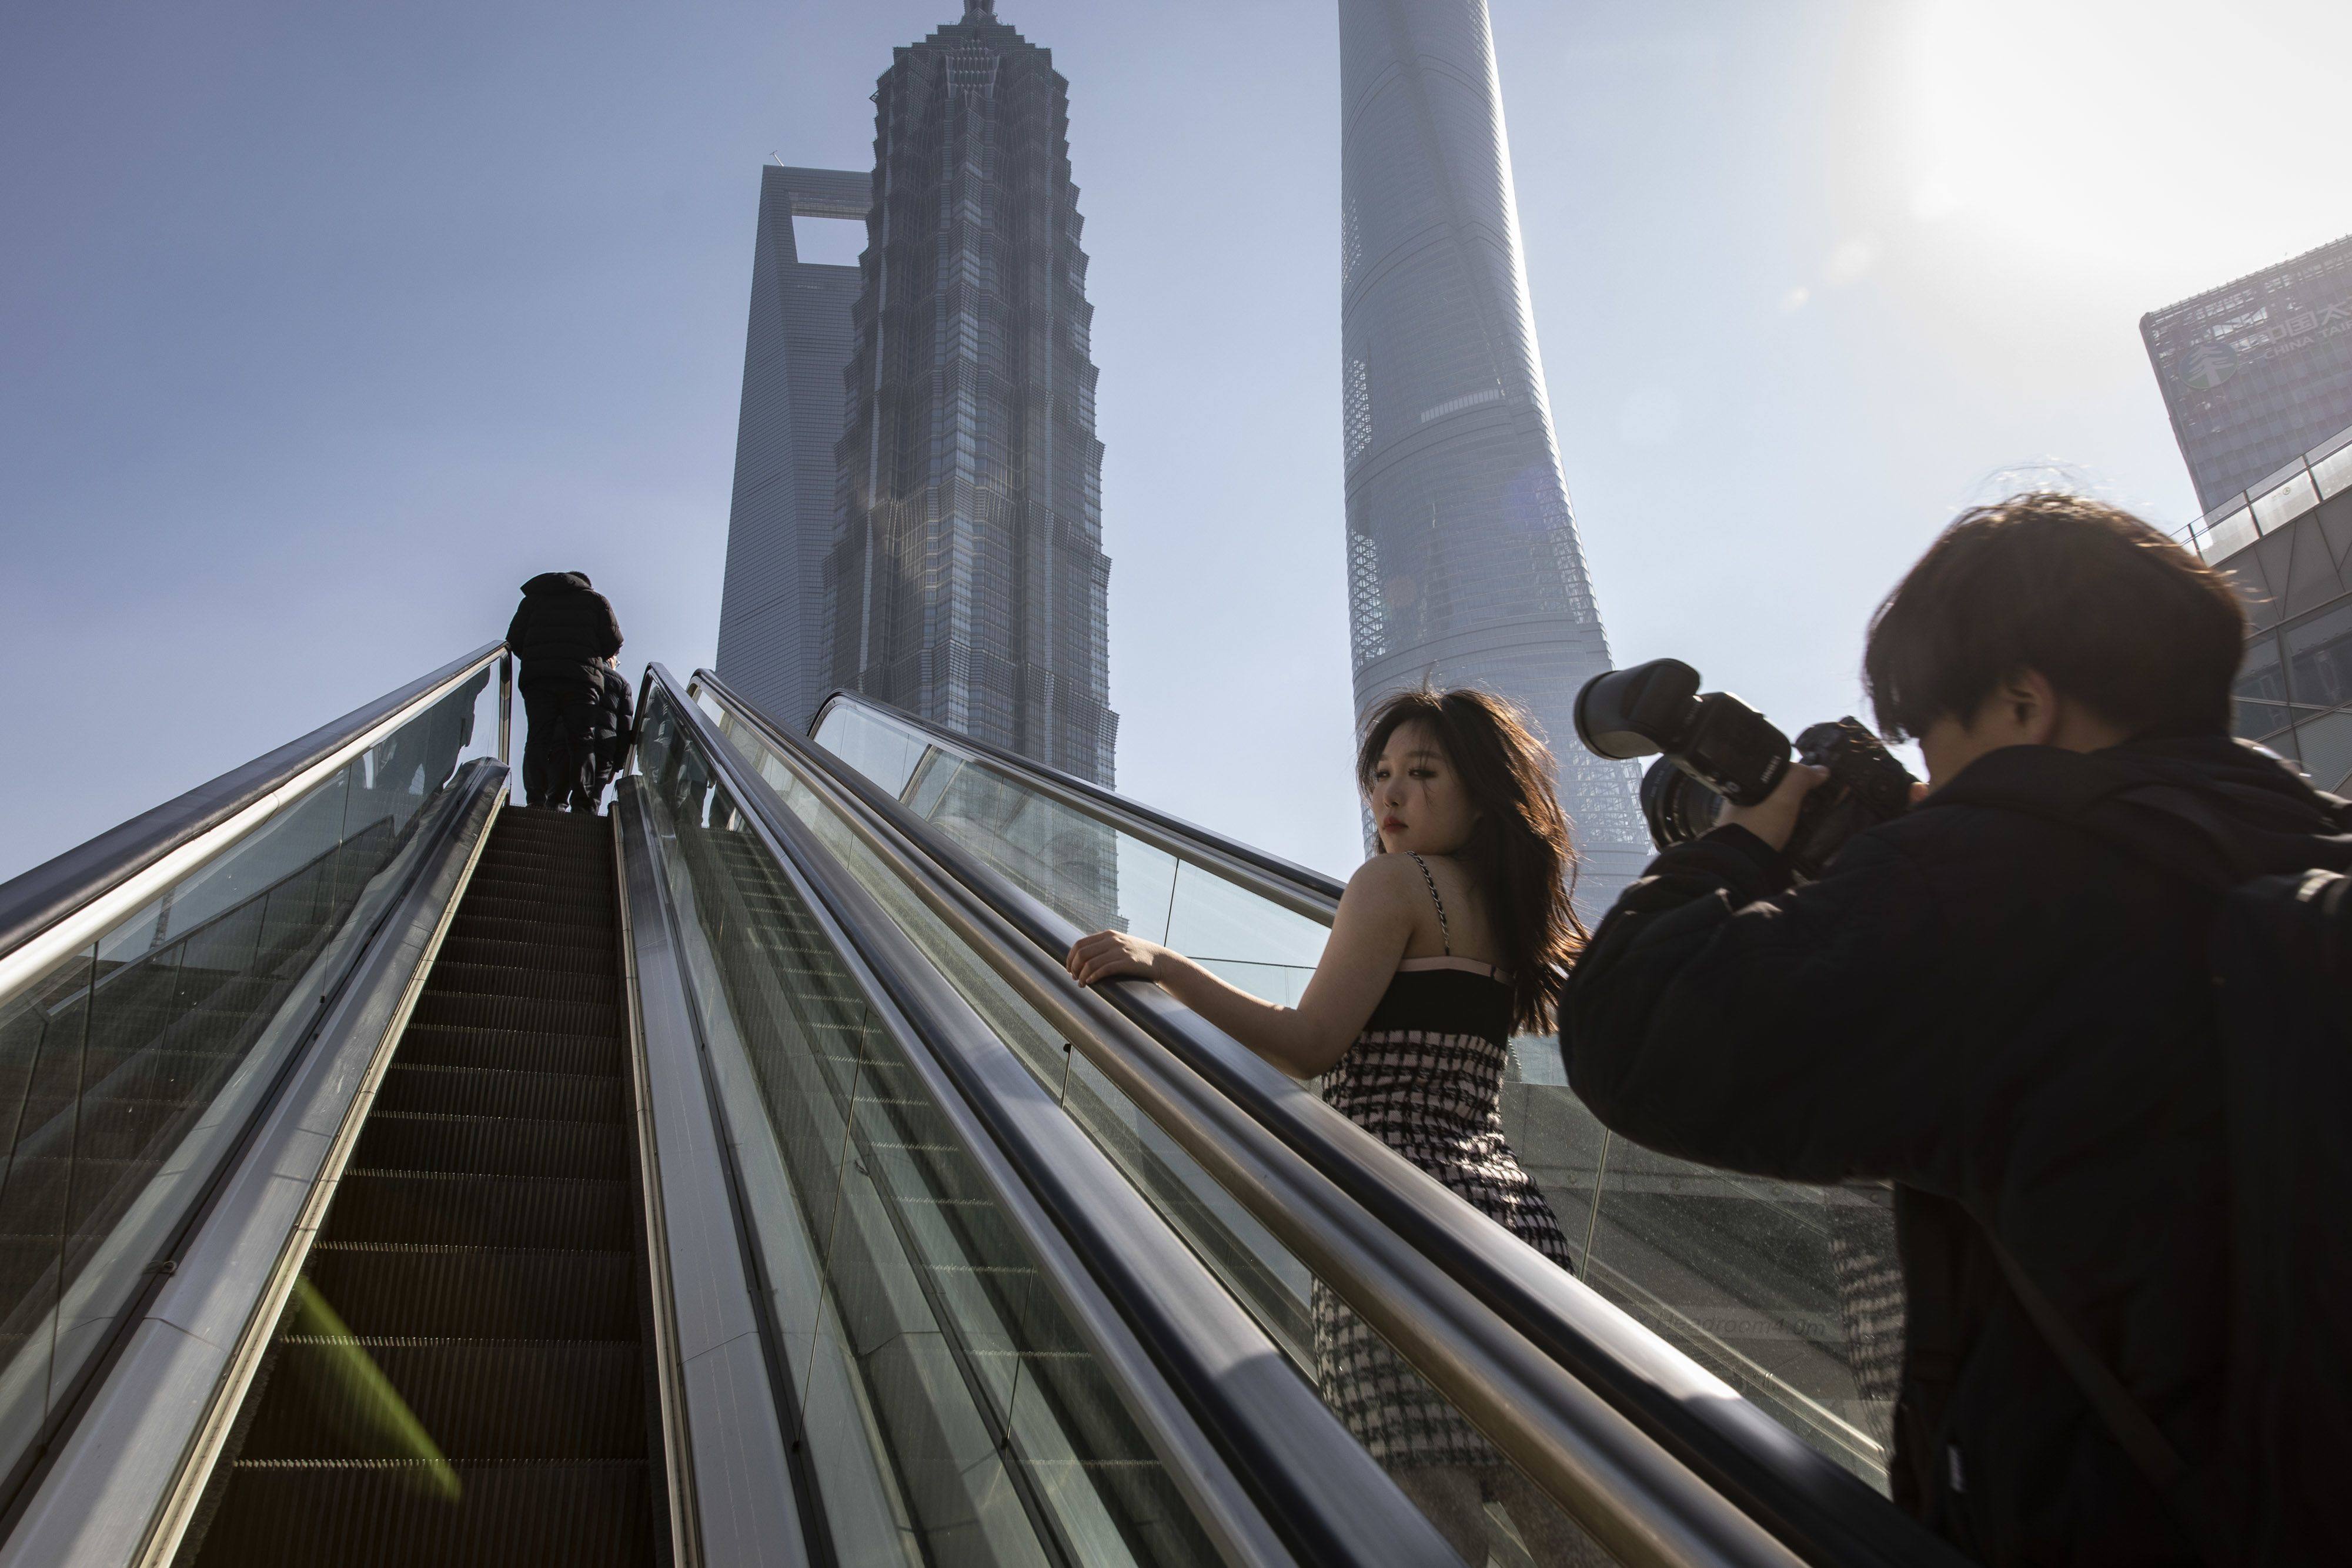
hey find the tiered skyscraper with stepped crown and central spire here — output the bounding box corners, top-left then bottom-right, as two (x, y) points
(826, 0), (1117, 785)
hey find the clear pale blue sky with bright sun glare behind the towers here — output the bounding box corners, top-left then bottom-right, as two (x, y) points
(0, 0), (2352, 877)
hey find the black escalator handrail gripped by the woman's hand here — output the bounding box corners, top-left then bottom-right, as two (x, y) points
(720, 670), (1957, 1563)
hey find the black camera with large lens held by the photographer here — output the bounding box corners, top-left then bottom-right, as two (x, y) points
(1576, 658), (1917, 881)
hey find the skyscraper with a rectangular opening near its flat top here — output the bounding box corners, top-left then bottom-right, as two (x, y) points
(717, 165), (873, 727)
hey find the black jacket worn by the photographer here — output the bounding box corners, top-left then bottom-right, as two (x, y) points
(1562, 736), (2352, 1563)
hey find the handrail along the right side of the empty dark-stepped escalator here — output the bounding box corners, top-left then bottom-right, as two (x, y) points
(647, 663), (1451, 1566)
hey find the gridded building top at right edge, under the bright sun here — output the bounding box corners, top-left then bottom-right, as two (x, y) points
(2140, 235), (2352, 513)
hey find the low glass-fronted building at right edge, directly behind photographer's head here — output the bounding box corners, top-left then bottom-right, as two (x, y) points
(2187, 423), (2352, 794)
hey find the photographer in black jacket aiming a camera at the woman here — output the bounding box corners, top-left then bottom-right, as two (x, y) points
(1562, 494), (2352, 1563)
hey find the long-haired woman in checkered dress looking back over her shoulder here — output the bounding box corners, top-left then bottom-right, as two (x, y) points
(1070, 689), (1588, 1566)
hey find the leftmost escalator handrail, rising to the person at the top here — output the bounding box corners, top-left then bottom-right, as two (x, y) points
(0, 642), (506, 997)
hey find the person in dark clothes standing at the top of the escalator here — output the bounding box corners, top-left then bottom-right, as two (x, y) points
(506, 571), (621, 806)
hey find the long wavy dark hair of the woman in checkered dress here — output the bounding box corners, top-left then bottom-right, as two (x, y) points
(1355, 687), (1585, 1032)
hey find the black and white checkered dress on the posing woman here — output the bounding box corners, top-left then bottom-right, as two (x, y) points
(1315, 907), (1571, 1469)
